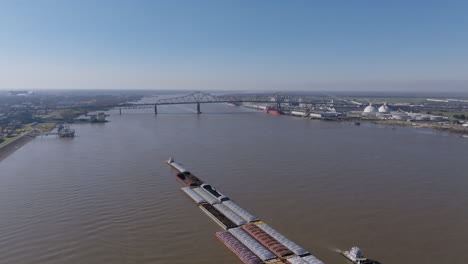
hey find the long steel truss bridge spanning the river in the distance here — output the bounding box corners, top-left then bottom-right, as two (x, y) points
(116, 92), (336, 114)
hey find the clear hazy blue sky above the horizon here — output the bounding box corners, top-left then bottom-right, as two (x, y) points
(0, 0), (468, 90)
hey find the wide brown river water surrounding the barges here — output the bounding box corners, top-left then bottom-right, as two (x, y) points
(0, 99), (468, 264)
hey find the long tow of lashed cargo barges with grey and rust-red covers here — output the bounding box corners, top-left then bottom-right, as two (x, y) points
(167, 157), (326, 264)
